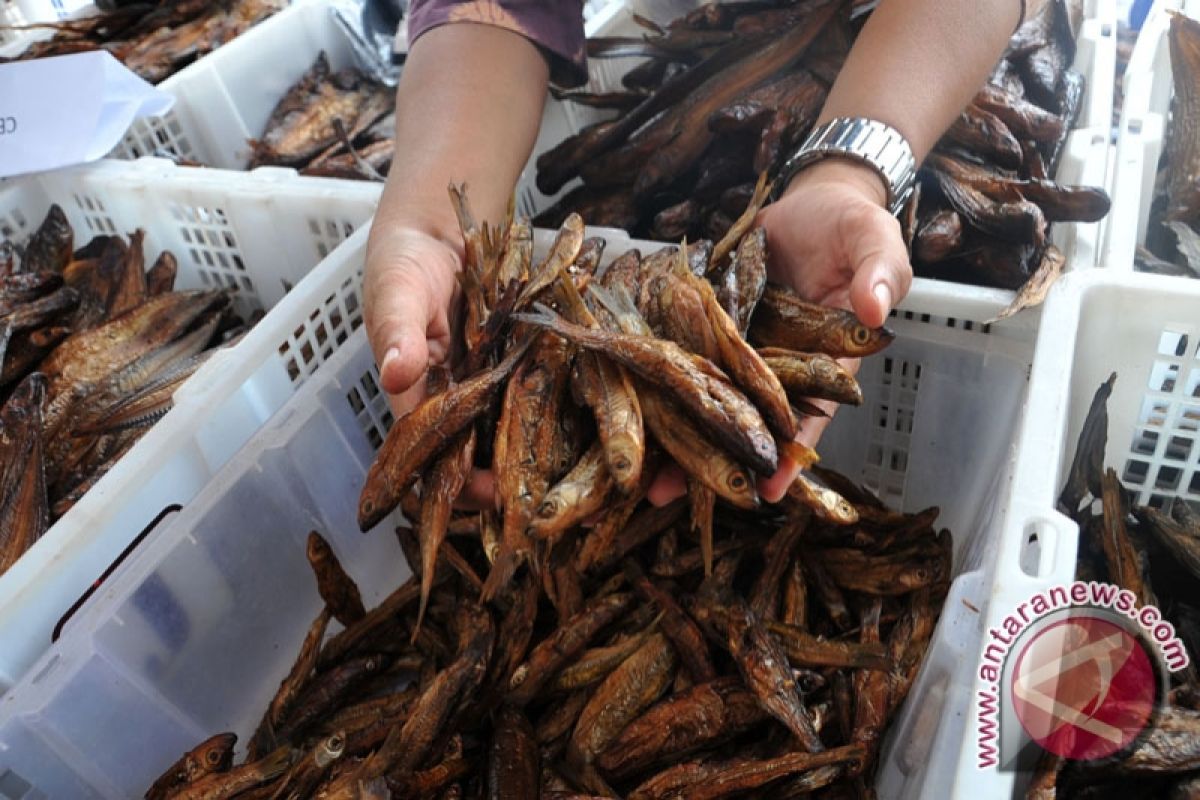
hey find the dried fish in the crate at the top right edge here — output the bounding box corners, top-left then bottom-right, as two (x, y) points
(1135, 12), (1200, 277)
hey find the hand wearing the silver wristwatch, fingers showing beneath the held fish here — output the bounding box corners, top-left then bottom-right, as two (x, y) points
(648, 158), (912, 505)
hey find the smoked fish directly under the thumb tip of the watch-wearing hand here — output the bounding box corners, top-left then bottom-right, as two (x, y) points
(750, 283), (895, 359)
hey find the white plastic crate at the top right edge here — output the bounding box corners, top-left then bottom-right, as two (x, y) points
(1103, 0), (1200, 270)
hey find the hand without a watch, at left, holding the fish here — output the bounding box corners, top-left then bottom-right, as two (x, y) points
(362, 217), (494, 509)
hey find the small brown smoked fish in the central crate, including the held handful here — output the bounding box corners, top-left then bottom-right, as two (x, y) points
(146, 190), (952, 800)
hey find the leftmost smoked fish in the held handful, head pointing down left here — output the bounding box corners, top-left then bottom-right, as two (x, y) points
(359, 343), (528, 531)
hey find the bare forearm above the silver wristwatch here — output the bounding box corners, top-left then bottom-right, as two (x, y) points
(818, 0), (1043, 163)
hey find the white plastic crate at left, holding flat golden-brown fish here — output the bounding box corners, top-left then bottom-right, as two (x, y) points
(0, 160), (379, 695)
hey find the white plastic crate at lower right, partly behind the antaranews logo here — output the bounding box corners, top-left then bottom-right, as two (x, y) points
(931, 270), (1200, 798)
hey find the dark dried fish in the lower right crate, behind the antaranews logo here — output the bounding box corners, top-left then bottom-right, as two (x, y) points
(1026, 373), (1200, 800)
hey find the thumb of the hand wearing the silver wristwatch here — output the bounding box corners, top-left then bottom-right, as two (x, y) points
(850, 207), (912, 327)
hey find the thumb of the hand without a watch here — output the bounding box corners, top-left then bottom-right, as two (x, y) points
(367, 266), (441, 395)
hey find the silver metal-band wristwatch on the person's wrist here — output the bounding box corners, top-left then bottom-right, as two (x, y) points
(775, 116), (917, 215)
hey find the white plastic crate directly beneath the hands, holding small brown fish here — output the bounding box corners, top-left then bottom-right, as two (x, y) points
(0, 217), (1073, 798)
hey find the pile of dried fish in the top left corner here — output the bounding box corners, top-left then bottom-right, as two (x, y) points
(0, 0), (286, 83)
